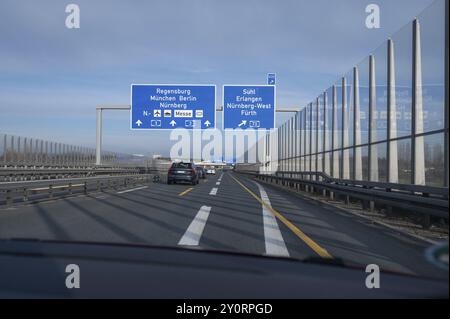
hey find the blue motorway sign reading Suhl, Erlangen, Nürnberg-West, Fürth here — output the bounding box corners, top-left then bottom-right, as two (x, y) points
(223, 85), (276, 130)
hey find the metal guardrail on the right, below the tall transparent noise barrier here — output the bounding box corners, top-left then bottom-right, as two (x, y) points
(240, 172), (449, 228)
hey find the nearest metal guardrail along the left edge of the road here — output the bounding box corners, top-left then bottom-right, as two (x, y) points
(0, 174), (154, 206)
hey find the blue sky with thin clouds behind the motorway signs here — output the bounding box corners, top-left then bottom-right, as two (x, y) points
(0, 0), (433, 155)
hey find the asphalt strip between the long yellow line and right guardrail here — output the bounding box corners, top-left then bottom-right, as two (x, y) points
(230, 172), (448, 277)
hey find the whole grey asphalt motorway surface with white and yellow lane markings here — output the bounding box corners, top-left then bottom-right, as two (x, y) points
(0, 172), (448, 277)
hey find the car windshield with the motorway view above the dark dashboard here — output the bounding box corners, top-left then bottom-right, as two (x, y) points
(0, 0), (449, 300)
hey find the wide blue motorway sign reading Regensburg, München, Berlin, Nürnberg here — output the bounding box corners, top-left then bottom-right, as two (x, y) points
(131, 84), (216, 130)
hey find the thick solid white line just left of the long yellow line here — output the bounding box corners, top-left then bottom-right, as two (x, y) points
(255, 182), (289, 257)
